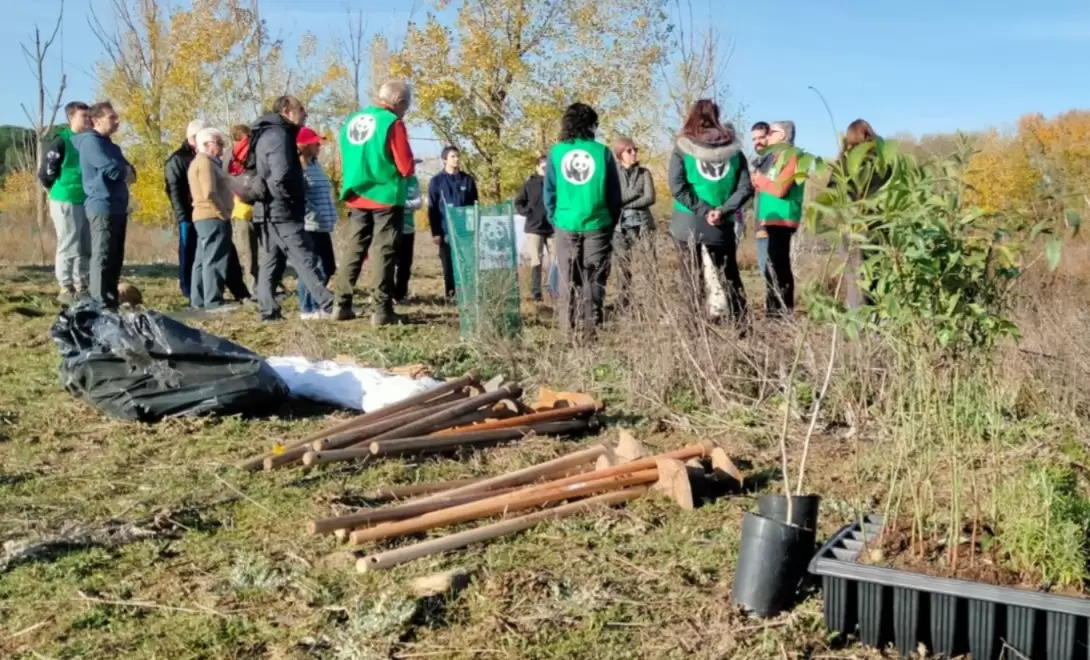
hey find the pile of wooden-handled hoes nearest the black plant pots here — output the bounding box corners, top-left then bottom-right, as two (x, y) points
(307, 431), (742, 573)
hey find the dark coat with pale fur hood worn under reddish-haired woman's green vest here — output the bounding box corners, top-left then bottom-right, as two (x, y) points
(669, 137), (753, 245)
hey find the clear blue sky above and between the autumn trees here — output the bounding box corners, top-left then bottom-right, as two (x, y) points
(0, 0), (1090, 154)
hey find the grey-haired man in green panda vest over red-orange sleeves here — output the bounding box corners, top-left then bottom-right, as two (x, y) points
(336, 81), (416, 327)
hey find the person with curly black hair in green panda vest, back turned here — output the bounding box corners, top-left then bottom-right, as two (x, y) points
(544, 102), (621, 334)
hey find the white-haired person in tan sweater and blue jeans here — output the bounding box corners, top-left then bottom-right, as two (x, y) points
(187, 129), (234, 309)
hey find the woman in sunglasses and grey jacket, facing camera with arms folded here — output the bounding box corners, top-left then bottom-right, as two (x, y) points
(613, 137), (655, 309)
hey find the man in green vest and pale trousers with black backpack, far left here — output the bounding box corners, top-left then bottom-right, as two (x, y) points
(38, 101), (90, 305)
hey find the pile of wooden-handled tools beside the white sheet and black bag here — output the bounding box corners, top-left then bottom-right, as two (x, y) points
(238, 374), (601, 470)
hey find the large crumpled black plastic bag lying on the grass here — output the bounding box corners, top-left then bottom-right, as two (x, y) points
(50, 302), (288, 423)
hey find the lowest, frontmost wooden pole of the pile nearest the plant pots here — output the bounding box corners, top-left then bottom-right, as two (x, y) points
(355, 486), (647, 573)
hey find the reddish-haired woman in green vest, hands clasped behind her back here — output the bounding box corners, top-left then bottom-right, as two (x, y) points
(668, 99), (753, 325)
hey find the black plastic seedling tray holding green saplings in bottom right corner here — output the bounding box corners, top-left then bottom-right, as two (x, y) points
(810, 515), (1090, 660)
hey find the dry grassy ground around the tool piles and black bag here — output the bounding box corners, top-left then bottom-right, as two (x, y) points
(0, 229), (1086, 660)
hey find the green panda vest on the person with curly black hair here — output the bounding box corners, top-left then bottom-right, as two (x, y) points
(549, 139), (613, 232)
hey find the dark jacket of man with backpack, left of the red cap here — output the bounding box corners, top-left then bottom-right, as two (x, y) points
(246, 112), (306, 222)
